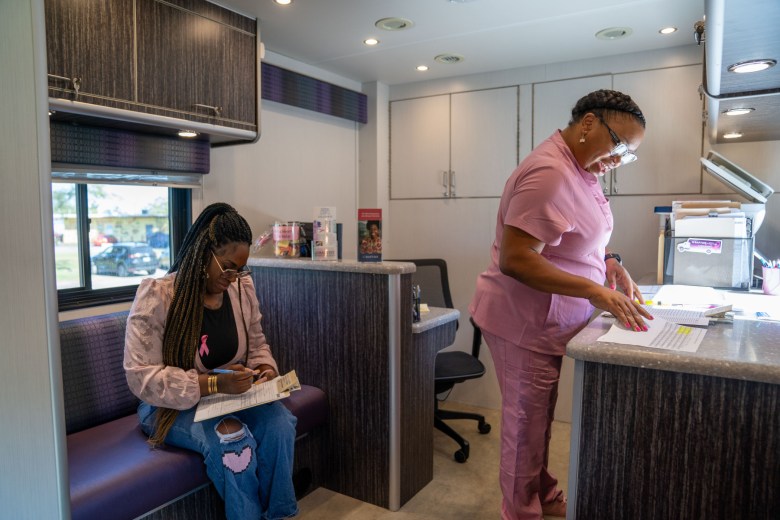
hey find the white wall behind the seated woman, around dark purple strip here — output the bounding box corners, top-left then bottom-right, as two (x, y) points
(209, 53), (359, 259)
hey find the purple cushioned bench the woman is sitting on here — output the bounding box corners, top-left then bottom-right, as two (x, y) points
(60, 312), (327, 520)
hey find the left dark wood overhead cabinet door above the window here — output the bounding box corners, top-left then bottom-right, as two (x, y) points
(44, 0), (135, 104)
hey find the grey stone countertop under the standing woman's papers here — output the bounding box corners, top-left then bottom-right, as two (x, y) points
(566, 315), (780, 384)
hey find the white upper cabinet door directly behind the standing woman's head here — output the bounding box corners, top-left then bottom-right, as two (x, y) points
(533, 74), (612, 193)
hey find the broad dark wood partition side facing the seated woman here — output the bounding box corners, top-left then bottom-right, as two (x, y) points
(252, 267), (390, 507)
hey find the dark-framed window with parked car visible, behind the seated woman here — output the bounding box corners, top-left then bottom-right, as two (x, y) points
(52, 181), (190, 310)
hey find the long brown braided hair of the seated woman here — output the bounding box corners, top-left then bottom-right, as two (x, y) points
(149, 202), (252, 446)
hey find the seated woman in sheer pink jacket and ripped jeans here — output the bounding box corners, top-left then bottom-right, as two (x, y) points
(124, 203), (298, 520)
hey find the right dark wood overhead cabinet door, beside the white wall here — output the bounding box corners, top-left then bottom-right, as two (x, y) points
(137, 0), (258, 124)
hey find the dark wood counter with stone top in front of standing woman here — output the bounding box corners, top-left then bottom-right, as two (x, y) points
(567, 310), (780, 520)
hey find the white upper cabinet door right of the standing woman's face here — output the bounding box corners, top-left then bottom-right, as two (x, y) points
(612, 65), (703, 195)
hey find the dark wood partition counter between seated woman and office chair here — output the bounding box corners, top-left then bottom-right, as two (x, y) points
(248, 258), (459, 511)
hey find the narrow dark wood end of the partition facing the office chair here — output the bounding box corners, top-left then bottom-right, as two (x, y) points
(401, 318), (457, 504)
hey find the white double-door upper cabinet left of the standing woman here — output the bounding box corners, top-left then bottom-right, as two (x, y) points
(390, 87), (518, 199)
